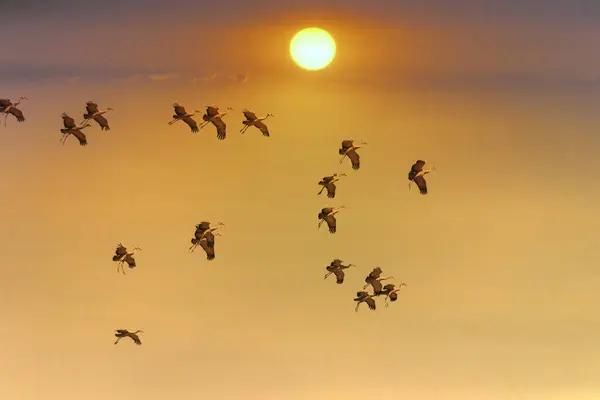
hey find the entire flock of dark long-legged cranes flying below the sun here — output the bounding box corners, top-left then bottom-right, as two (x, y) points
(0, 97), (435, 345)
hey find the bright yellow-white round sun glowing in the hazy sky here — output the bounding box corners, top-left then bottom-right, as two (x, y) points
(290, 28), (336, 71)
